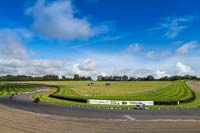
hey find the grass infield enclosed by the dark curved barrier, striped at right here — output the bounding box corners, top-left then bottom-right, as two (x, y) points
(50, 81), (192, 101)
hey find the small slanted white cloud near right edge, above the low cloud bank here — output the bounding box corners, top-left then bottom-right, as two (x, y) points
(176, 41), (198, 54)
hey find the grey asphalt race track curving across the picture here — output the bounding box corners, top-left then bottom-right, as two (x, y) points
(0, 86), (200, 120)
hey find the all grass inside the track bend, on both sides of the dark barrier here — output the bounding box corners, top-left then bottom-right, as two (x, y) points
(0, 81), (200, 108)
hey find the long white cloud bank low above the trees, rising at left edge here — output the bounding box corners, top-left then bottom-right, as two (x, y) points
(0, 29), (200, 78)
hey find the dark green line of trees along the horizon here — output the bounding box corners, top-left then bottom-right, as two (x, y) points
(0, 74), (200, 81)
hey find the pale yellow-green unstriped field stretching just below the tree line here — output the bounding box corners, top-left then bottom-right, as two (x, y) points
(10, 81), (171, 96)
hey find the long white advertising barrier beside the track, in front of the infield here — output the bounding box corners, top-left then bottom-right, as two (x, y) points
(87, 99), (154, 105)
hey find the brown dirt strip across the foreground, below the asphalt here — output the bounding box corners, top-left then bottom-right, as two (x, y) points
(0, 105), (200, 133)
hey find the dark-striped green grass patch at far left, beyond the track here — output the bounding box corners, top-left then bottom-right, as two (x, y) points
(0, 84), (36, 96)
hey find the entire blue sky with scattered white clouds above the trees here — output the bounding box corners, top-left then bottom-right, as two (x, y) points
(0, 0), (200, 78)
